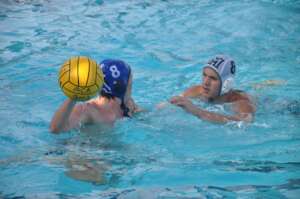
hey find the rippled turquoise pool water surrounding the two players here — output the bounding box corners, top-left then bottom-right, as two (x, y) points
(0, 0), (300, 199)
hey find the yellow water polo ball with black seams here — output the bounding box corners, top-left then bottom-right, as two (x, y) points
(58, 56), (104, 101)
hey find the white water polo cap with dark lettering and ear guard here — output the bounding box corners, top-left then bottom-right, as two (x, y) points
(204, 55), (235, 95)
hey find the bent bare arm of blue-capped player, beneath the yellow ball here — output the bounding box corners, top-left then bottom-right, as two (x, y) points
(50, 99), (84, 133)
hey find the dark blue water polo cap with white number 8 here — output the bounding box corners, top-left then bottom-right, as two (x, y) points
(100, 59), (131, 102)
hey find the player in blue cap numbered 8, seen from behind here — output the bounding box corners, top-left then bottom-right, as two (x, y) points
(50, 59), (140, 133)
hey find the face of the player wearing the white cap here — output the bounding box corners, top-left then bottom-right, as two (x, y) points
(202, 68), (221, 98)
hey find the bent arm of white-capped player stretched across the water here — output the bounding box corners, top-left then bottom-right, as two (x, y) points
(170, 96), (254, 123)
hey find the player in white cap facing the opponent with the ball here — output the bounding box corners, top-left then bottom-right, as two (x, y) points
(170, 55), (255, 122)
